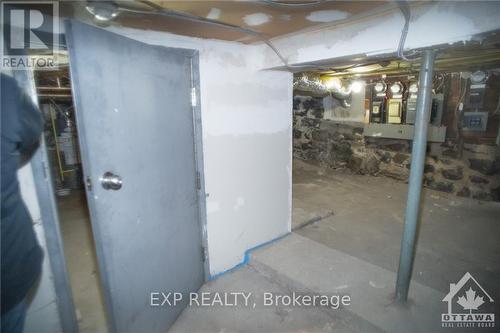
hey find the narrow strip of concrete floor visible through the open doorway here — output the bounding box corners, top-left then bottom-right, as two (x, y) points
(57, 191), (107, 333)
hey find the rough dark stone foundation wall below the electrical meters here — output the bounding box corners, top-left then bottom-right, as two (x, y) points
(293, 96), (500, 201)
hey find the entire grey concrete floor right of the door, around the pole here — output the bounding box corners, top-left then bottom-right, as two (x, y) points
(170, 161), (500, 332)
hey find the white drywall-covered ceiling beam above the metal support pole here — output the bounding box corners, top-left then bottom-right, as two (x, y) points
(266, 1), (500, 67)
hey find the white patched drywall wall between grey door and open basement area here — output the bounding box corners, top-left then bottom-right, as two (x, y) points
(108, 28), (292, 276)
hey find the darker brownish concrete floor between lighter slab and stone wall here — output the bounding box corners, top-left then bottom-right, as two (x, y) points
(293, 161), (500, 298)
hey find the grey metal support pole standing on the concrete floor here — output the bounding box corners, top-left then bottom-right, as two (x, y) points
(396, 50), (435, 303)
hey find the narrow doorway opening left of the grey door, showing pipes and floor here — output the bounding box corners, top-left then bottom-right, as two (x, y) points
(35, 67), (107, 332)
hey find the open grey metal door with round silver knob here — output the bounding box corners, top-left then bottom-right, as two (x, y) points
(66, 21), (204, 332)
